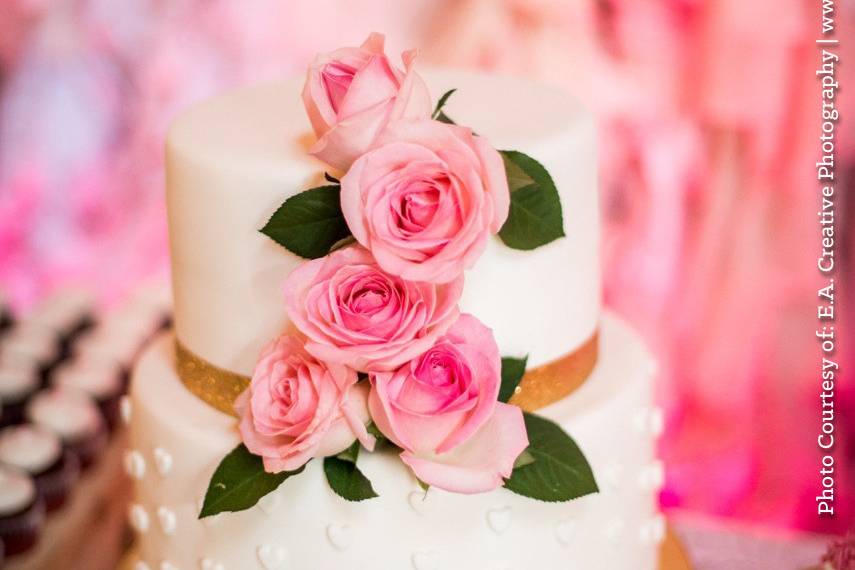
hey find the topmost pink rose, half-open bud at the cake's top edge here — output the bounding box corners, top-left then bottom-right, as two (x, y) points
(303, 34), (432, 171)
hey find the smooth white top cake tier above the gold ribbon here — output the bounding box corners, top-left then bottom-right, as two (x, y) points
(166, 71), (600, 375)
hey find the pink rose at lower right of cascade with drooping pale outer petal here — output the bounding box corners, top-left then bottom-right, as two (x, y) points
(368, 314), (528, 493)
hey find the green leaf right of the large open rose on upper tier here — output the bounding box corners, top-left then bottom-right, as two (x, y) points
(499, 150), (564, 250)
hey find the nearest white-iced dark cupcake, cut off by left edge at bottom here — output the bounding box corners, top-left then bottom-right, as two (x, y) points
(0, 466), (45, 558)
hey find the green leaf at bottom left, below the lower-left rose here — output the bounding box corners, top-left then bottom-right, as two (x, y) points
(199, 444), (303, 519)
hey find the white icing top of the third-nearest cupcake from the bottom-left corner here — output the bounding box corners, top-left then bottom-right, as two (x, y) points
(27, 388), (103, 441)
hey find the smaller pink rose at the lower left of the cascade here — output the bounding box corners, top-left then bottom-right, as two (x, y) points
(235, 335), (374, 473)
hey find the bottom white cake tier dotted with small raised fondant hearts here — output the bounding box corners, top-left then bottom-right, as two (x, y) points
(125, 315), (665, 570)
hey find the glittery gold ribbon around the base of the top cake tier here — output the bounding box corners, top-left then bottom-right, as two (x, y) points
(175, 333), (599, 416)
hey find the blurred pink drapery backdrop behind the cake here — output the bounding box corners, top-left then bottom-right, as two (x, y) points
(0, 0), (855, 531)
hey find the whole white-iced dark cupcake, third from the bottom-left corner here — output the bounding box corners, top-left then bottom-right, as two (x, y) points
(26, 388), (107, 471)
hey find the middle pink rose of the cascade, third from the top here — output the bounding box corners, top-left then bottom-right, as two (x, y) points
(285, 246), (463, 371)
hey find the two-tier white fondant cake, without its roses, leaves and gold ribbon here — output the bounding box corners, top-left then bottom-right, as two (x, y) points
(123, 67), (664, 570)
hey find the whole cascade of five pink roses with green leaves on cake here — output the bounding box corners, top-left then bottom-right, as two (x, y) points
(200, 34), (597, 517)
